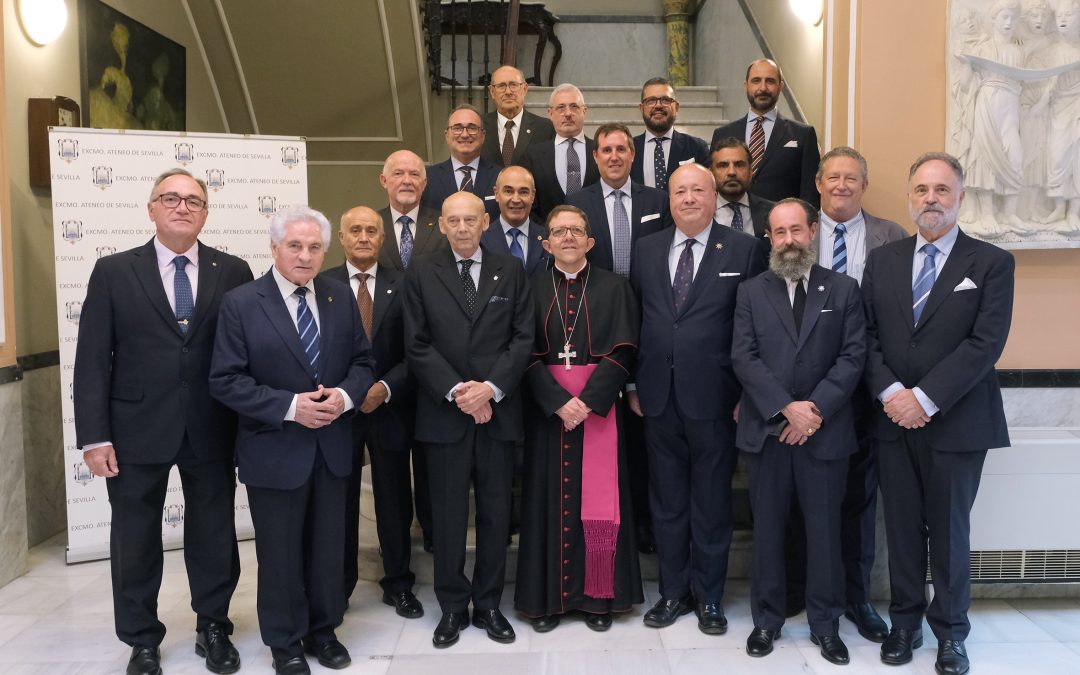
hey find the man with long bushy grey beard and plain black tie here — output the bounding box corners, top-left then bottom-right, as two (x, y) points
(731, 199), (866, 665)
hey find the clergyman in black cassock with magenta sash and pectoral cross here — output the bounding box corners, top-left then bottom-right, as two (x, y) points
(514, 205), (644, 633)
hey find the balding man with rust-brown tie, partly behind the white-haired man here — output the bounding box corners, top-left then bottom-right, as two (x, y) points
(323, 206), (423, 619)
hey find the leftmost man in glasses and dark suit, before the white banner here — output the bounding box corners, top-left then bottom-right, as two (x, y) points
(73, 168), (252, 675)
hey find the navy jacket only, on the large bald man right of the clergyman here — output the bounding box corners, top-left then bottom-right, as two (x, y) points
(630, 222), (766, 419)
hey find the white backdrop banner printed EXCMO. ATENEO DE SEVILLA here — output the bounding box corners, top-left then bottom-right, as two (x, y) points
(49, 127), (308, 563)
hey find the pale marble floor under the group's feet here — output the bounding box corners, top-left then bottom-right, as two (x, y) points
(0, 537), (1080, 675)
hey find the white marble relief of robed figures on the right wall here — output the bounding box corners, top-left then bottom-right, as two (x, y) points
(946, 0), (1080, 248)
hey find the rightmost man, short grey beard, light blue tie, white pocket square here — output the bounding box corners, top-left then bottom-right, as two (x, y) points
(862, 152), (1015, 675)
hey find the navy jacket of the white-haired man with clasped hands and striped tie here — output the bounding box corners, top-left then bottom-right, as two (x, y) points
(210, 272), (375, 489)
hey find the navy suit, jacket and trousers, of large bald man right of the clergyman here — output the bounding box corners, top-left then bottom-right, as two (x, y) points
(630, 222), (766, 603)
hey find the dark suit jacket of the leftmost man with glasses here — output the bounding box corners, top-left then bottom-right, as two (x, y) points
(72, 239), (252, 464)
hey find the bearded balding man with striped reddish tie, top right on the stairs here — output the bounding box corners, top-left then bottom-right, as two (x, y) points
(710, 58), (821, 208)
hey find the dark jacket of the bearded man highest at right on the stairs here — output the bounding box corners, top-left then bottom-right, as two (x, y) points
(710, 113), (821, 207)
